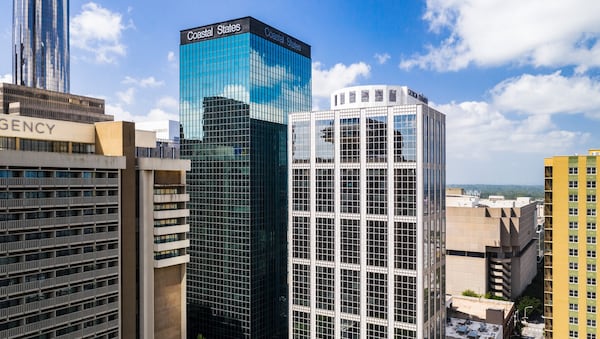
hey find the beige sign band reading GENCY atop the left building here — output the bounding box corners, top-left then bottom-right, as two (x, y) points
(0, 114), (96, 144)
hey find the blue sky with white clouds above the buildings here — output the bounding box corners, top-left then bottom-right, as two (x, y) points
(0, 0), (600, 184)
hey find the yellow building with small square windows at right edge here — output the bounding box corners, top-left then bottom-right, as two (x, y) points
(544, 150), (600, 339)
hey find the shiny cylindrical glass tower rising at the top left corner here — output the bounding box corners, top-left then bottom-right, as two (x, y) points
(13, 0), (69, 93)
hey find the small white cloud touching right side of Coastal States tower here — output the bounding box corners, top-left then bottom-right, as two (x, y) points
(312, 61), (371, 98)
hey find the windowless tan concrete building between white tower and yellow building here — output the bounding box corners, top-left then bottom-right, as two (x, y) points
(446, 192), (538, 299)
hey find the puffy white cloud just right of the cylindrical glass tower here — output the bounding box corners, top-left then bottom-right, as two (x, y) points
(70, 2), (133, 63)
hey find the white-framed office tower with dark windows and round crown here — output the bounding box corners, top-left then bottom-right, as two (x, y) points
(288, 86), (446, 339)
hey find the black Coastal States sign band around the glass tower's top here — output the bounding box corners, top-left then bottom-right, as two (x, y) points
(180, 17), (310, 57)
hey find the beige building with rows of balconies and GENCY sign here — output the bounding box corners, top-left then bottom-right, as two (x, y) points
(0, 105), (190, 338)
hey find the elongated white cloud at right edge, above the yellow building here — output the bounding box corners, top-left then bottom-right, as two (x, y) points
(490, 72), (600, 118)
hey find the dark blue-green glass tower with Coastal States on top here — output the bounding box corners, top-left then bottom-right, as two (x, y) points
(180, 17), (311, 338)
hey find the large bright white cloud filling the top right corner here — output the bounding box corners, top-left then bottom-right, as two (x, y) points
(400, 0), (600, 72)
